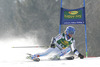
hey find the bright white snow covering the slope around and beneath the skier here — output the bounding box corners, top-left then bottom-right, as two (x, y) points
(0, 38), (100, 67)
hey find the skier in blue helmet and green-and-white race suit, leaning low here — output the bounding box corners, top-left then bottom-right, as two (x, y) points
(27, 26), (84, 61)
